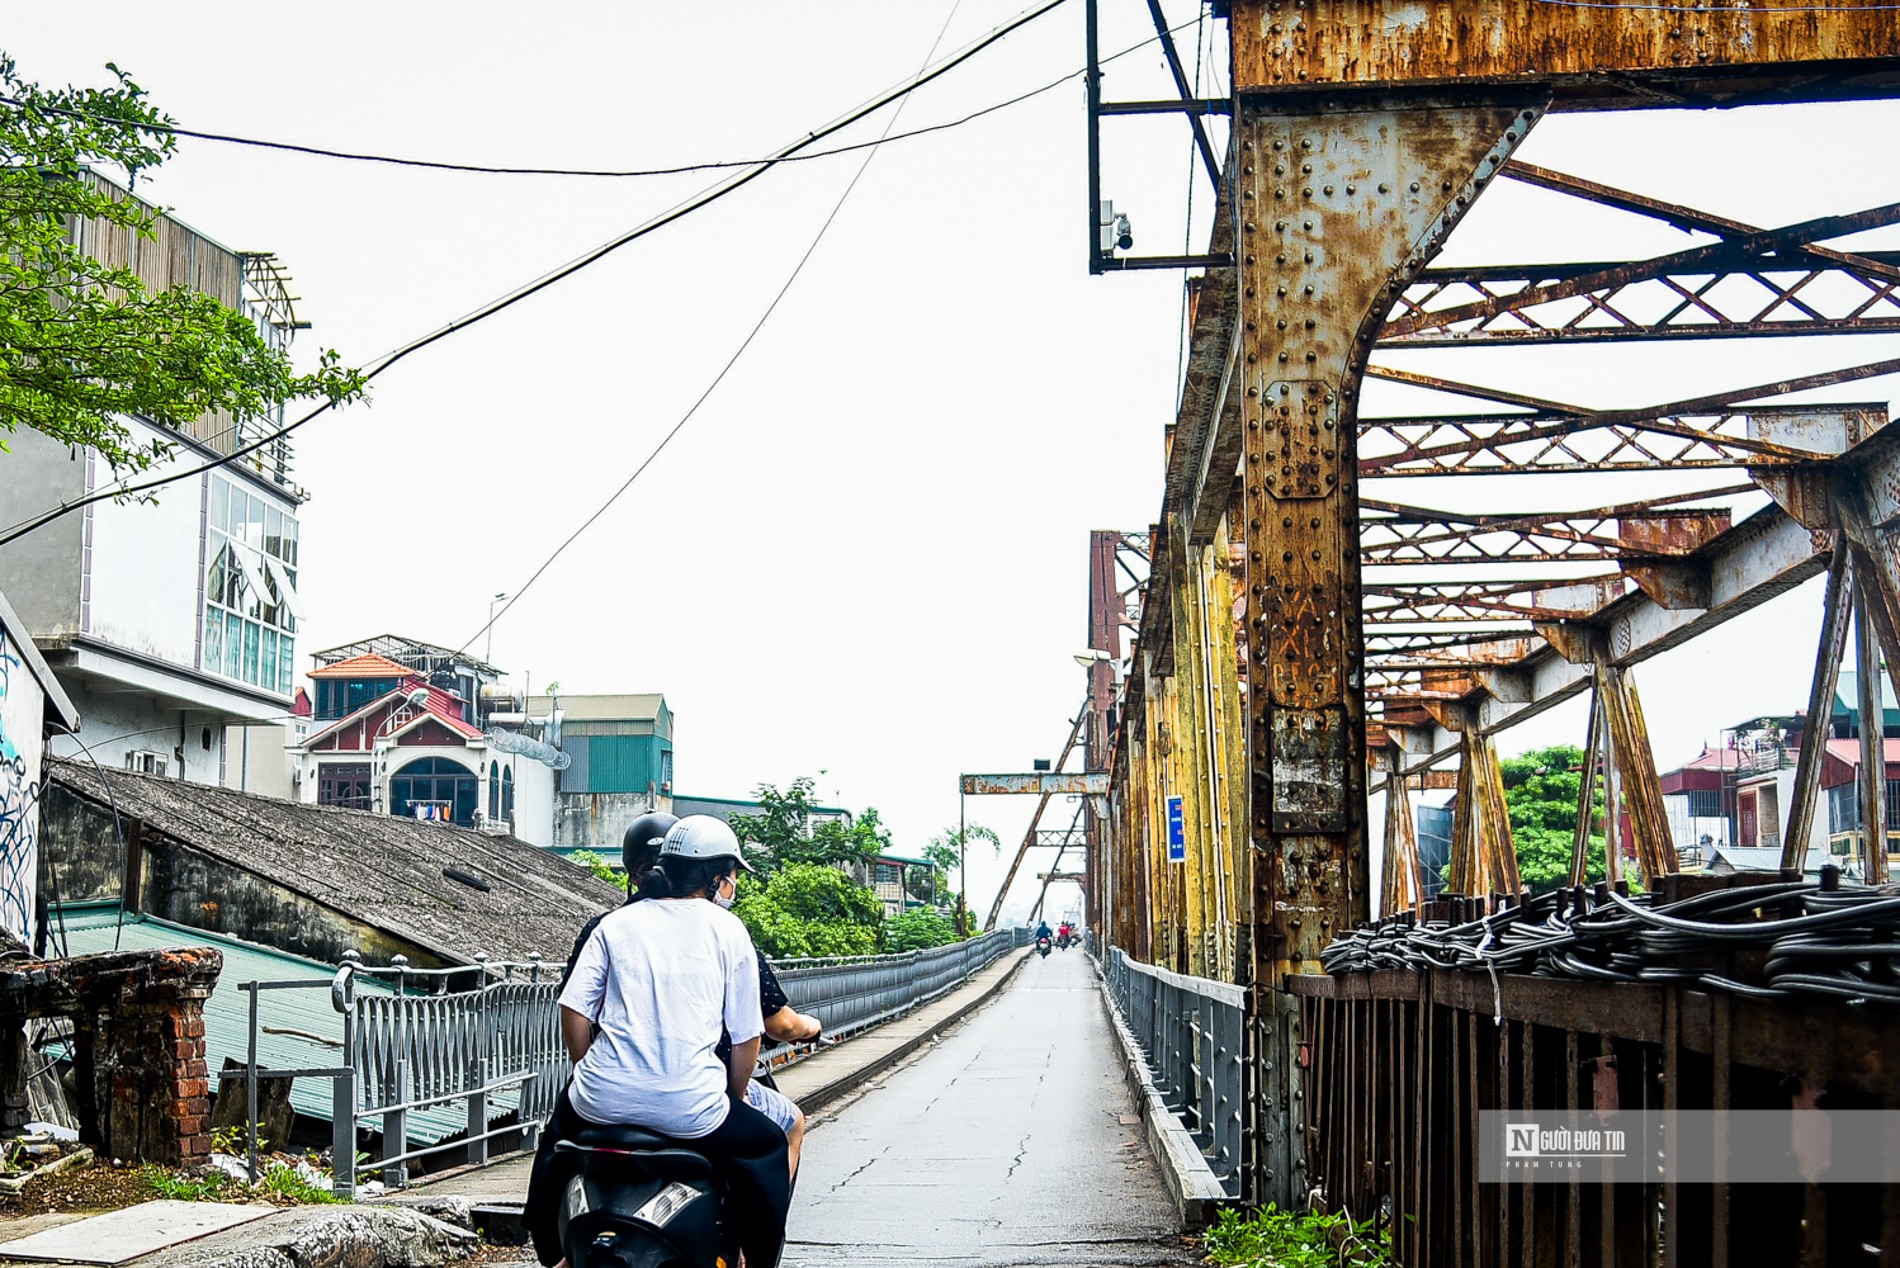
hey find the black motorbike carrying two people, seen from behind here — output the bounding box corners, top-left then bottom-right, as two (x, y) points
(555, 1072), (777, 1268)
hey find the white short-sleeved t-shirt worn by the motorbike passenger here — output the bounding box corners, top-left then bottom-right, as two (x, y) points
(561, 899), (764, 1139)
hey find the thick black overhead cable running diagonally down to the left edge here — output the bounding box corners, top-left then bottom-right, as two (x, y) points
(0, 0), (1072, 546)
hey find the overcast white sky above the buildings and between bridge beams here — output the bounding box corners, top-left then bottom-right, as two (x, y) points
(11, 0), (1900, 923)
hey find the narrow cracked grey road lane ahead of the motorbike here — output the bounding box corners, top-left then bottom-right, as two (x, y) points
(785, 951), (1197, 1268)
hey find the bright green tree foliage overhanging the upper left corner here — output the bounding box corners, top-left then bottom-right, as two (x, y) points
(0, 55), (363, 471)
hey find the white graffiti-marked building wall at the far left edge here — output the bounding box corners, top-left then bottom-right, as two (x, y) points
(0, 581), (80, 951)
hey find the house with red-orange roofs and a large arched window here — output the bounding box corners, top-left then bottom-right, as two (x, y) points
(289, 635), (570, 846)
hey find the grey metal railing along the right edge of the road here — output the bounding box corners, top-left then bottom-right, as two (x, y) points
(1102, 947), (1246, 1198)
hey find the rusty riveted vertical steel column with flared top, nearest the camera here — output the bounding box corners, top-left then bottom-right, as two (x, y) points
(1235, 93), (1545, 989)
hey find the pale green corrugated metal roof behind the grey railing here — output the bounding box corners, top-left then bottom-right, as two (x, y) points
(48, 905), (517, 1144)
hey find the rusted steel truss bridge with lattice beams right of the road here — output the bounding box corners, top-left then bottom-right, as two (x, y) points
(1081, 0), (1900, 1264)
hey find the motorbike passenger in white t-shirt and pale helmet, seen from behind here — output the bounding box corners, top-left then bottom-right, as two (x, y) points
(523, 816), (790, 1268)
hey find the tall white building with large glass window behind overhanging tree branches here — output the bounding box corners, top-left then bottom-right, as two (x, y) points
(0, 173), (315, 783)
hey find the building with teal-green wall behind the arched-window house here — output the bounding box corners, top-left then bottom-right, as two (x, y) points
(543, 692), (676, 857)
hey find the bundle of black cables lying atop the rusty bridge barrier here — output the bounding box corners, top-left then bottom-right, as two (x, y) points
(1321, 867), (1900, 1004)
